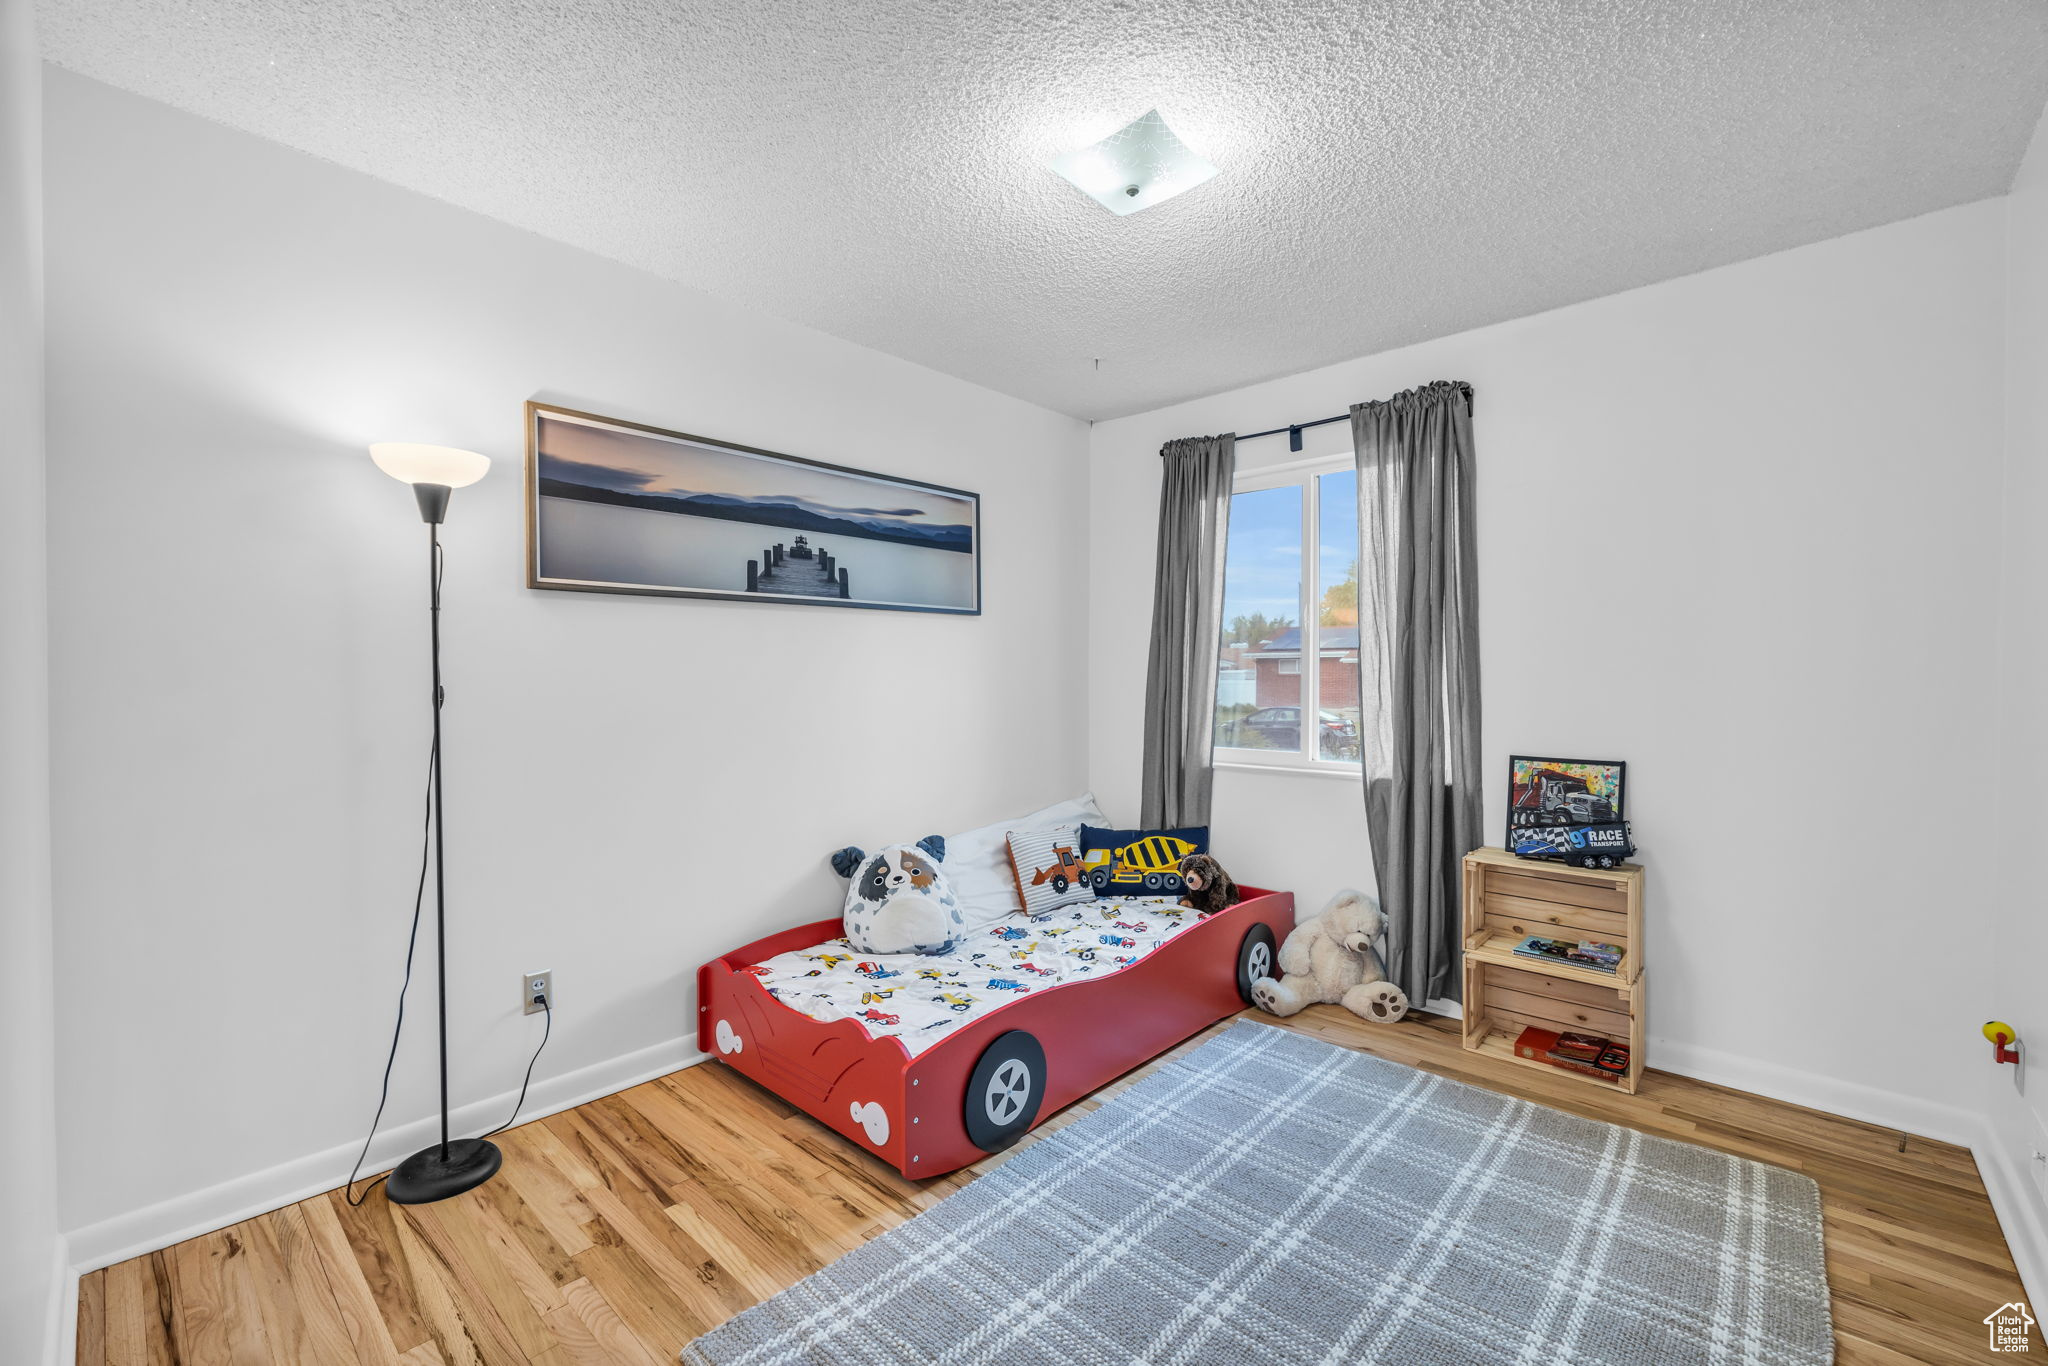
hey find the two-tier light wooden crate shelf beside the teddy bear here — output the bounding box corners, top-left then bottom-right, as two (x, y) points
(1464, 850), (1642, 1092)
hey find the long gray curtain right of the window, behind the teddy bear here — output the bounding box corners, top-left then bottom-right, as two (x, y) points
(1352, 381), (1481, 1006)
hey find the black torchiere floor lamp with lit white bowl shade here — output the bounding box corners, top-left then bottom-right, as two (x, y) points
(371, 440), (504, 1204)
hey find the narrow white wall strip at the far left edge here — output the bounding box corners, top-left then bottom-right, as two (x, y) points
(0, 0), (63, 1362)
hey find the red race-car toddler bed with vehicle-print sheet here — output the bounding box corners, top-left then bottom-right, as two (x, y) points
(696, 887), (1294, 1180)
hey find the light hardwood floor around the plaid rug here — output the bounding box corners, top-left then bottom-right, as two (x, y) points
(78, 1006), (2023, 1366)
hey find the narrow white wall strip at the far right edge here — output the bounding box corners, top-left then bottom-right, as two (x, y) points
(1974, 98), (2048, 1303)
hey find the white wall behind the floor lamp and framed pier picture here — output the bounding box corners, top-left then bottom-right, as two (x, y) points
(47, 70), (1085, 1262)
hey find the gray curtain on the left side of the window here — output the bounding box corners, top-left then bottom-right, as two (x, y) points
(1139, 432), (1237, 829)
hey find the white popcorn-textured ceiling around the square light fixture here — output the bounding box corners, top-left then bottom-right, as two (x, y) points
(39, 0), (2048, 418)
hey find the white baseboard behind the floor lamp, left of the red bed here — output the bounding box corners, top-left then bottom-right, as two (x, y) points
(68, 1036), (709, 1269)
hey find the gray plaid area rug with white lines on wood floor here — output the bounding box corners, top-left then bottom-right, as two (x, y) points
(682, 1022), (1835, 1366)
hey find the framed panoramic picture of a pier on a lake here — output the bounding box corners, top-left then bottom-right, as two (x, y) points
(526, 403), (981, 614)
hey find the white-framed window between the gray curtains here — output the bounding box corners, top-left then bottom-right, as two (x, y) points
(1217, 455), (1360, 772)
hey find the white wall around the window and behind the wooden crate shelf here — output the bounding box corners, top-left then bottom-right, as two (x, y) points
(1090, 201), (2007, 1139)
